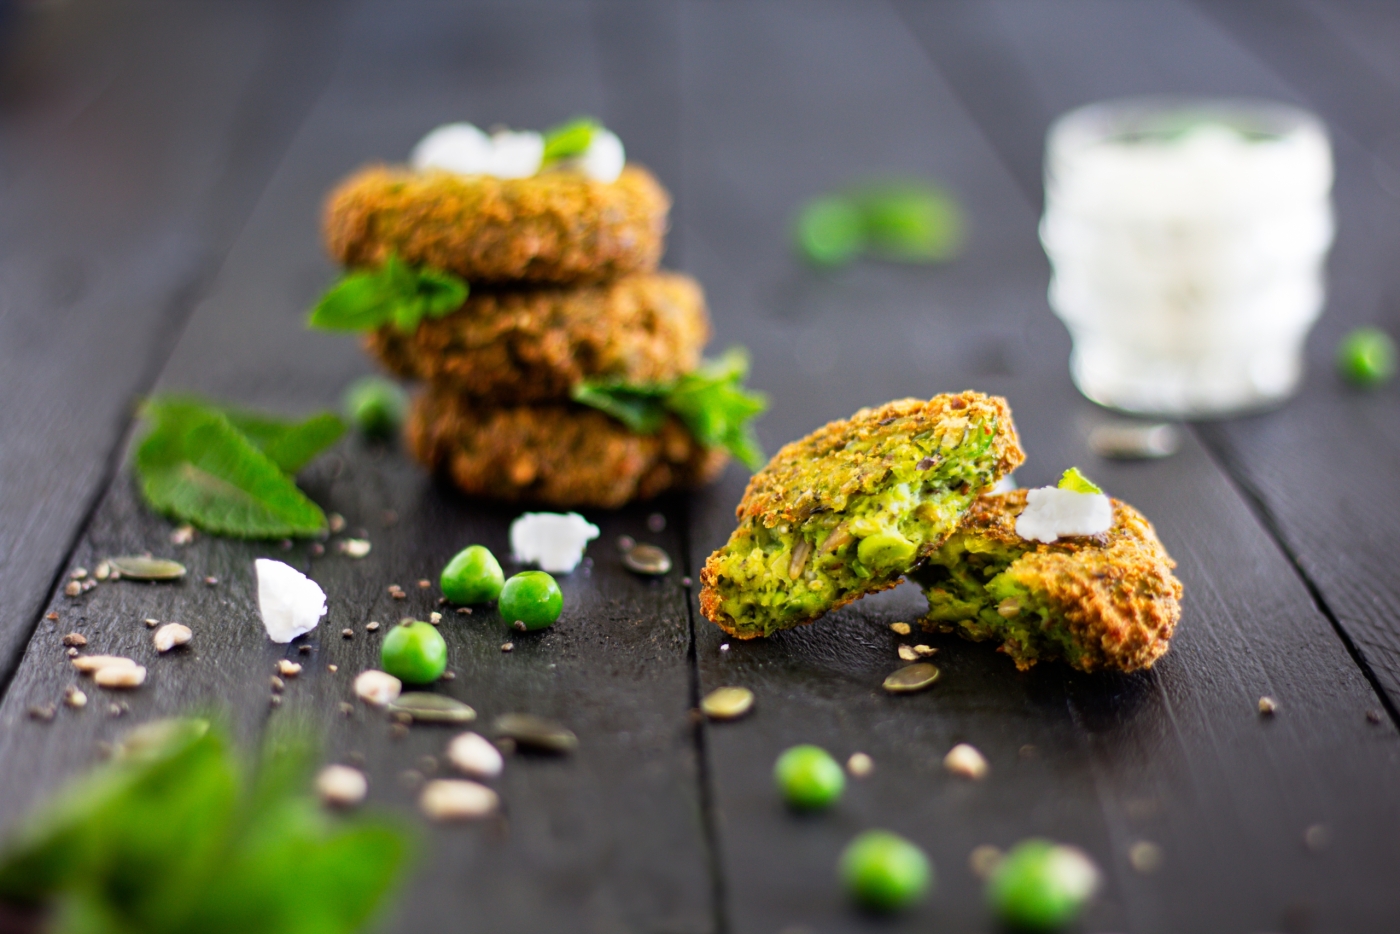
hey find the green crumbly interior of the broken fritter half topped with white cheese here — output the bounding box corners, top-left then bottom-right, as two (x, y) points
(910, 532), (1082, 664)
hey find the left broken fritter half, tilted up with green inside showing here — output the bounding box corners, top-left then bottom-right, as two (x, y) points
(700, 392), (1025, 639)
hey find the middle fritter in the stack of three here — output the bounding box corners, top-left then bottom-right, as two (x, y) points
(365, 273), (710, 405)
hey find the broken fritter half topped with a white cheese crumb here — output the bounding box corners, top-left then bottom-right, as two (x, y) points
(911, 490), (1182, 671)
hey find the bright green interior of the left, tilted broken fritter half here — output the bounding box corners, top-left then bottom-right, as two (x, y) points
(718, 421), (998, 636)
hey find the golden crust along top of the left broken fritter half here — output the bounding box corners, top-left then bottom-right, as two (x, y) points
(735, 391), (1026, 528)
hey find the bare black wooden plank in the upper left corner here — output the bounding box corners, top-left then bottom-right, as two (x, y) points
(0, 3), (350, 678)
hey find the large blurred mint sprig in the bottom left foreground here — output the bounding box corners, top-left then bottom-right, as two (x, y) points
(0, 720), (412, 934)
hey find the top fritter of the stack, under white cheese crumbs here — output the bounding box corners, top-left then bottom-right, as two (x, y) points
(325, 165), (671, 286)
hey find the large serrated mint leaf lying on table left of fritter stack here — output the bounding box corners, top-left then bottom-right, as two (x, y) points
(134, 398), (328, 538)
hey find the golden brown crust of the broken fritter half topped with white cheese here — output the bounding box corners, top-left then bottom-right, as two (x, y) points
(940, 490), (1182, 672)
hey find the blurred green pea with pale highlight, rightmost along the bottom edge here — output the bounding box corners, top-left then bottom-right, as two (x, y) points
(987, 839), (1099, 931)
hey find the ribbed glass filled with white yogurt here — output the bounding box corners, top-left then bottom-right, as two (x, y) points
(1040, 98), (1333, 417)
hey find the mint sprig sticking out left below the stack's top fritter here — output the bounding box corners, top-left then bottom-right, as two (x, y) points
(309, 253), (469, 333)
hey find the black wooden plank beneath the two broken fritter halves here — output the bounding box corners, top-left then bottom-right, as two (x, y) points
(683, 4), (1400, 931)
